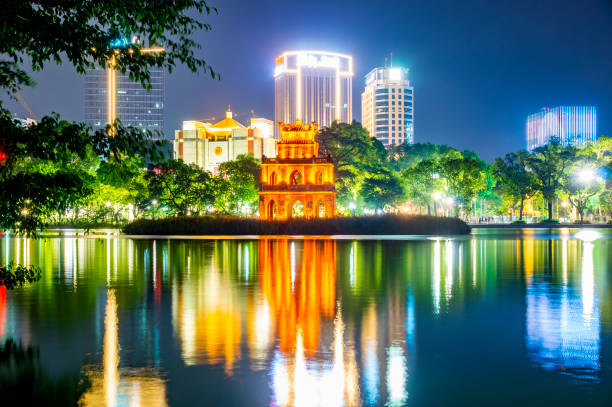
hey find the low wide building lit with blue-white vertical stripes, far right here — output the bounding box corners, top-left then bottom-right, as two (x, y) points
(527, 106), (597, 151)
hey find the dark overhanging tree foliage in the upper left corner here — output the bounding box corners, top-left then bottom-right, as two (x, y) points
(0, 0), (217, 90)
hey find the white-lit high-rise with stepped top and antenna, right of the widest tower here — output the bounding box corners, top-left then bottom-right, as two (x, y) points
(361, 67), (414, 148)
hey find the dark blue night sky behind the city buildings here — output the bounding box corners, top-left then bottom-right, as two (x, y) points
(5, 0), (612, 161)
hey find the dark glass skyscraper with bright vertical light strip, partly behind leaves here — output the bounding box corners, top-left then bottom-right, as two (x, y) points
(84, 67), (164, 132)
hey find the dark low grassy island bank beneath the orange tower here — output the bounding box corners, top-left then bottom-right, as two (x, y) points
(122, 215), (470, 235)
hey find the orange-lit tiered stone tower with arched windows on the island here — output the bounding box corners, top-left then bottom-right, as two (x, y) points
(259, 119), (336, 220)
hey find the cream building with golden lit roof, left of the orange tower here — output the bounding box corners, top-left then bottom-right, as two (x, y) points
(174, 109), (276, 172)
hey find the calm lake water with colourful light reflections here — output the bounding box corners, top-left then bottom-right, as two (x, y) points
(0, 229), (612, 406)
